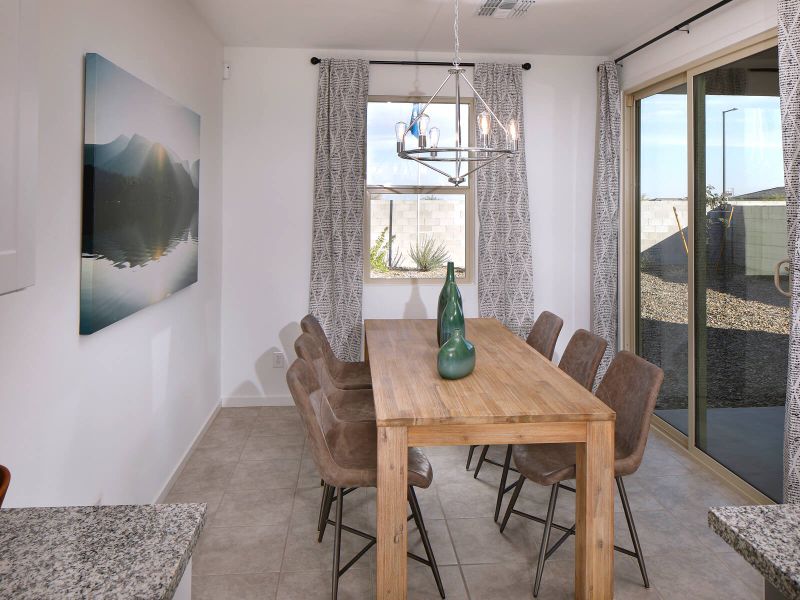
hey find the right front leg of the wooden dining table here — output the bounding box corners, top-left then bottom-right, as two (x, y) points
(575, 421), (614, 600)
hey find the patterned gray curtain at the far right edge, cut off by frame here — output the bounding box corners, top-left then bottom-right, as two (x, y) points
(778, 0), (800, 504)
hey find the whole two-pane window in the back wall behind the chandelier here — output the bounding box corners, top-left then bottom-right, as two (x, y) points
(364, 97), (473, 282)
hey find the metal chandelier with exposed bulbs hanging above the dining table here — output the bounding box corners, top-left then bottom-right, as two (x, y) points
(394, 0), (519, 186)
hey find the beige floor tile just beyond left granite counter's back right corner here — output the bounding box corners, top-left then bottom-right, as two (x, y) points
(210, 489), (294, 527)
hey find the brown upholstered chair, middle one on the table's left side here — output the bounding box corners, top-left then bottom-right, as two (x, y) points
(294, 333), (375, 421)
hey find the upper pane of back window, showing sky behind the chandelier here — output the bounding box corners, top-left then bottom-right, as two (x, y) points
(367, 102), (471, 187)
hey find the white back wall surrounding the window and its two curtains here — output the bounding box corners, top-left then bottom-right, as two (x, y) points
(222, 48), (602, 404)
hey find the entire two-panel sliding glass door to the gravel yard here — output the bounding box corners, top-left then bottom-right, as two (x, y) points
(629, 38), (790, 501)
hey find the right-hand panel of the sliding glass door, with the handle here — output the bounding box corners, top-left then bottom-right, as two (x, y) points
(693, 48), (790, 500)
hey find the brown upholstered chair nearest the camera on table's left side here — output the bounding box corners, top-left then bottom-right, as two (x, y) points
(286, 358), (445, 600)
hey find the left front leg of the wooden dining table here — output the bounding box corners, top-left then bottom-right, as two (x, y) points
(377, 427), (408, 600)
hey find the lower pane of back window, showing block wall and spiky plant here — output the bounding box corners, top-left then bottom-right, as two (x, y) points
(369, 193), (467, 279)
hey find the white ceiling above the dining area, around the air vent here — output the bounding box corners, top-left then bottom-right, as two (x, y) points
(189, 0), (713, 56)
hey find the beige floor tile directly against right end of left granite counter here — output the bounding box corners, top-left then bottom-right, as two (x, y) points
(192, 525), (286, 575)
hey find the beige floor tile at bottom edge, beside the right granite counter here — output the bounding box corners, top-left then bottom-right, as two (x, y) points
(647, 551), (759, 600)
